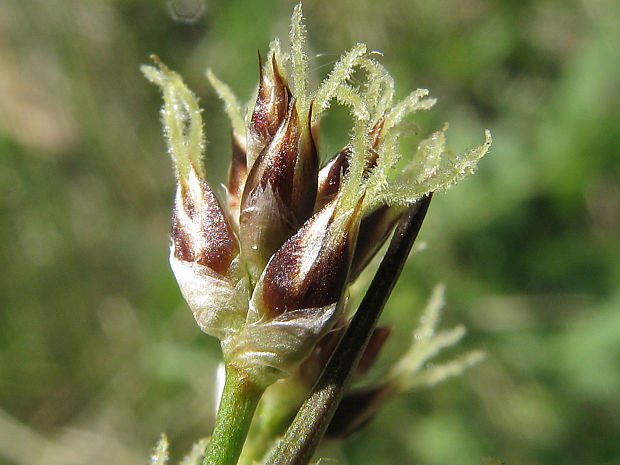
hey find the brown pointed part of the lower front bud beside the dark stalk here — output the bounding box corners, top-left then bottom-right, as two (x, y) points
(262, 191), (361, 317)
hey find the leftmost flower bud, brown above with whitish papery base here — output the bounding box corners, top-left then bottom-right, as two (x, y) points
(170, 164), (247, 339)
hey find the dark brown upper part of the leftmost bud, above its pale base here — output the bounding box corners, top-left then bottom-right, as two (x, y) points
(171, 162), (239, 275)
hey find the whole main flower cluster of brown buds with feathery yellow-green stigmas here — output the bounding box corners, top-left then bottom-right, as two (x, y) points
(143, 6), (490, 387)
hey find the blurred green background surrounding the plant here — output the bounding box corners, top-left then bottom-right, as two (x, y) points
(0, 0), (620, 465)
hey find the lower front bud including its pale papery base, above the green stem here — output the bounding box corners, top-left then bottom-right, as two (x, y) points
(231, 192), (362, 385)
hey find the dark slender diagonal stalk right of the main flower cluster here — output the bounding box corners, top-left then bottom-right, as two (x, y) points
(267, 194), (432, 465)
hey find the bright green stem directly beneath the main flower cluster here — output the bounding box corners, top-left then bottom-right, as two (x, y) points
(203, 364), (264, 465)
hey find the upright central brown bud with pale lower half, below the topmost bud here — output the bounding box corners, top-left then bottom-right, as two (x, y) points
(239, 101), (318, 280)
